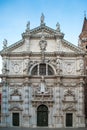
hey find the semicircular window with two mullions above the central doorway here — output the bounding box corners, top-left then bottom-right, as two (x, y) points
(31, 63), (54, 75)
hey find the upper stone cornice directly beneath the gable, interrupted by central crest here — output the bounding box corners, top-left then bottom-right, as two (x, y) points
(1, 51), (85, 57)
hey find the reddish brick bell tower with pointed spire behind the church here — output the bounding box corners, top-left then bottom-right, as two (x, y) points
(79, 15), (87, 125)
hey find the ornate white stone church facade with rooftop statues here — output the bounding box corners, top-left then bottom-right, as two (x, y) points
(0, 14), (85, 128)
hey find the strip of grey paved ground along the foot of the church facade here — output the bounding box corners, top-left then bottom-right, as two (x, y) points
(0, 127), (87, 130)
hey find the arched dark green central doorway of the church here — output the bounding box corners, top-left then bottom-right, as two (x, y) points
(37, 105), (48, 126)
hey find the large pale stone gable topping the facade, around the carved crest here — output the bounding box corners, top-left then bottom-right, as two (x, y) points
(1, 25), (84, 54)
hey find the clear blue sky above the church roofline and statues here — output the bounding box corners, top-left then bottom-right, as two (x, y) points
(0, 0), (87, 73)
